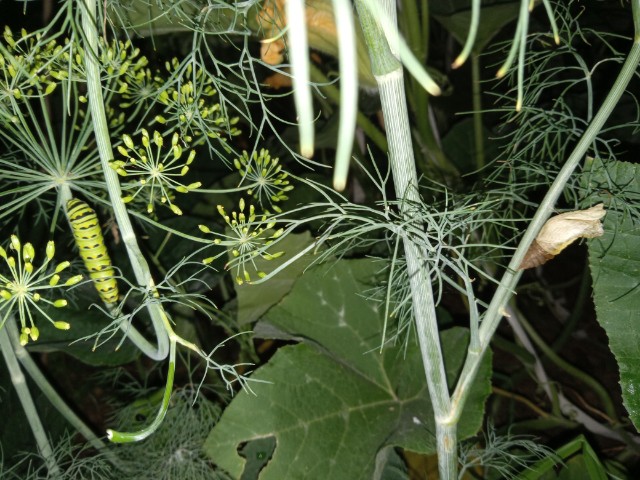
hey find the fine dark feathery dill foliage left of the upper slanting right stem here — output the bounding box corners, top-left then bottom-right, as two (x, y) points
(484, 4), (629, 219)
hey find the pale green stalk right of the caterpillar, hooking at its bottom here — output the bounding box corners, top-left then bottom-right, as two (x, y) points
(81, 0), (169, 360)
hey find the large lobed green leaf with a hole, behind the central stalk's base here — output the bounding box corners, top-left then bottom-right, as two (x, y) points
(204, 260), (491, 479)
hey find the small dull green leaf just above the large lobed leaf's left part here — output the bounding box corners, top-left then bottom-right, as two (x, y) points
(236, 232), (313, 325)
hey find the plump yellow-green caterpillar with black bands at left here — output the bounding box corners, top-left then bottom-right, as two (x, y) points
(67, 198), (118, 303)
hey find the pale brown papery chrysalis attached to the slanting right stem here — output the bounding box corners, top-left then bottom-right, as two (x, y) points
(518, 203), (606, 270)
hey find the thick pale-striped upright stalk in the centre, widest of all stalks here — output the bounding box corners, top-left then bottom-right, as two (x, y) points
(356, 0), (458, 479)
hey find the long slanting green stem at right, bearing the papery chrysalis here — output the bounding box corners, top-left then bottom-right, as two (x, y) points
(451, 6), (640, 420)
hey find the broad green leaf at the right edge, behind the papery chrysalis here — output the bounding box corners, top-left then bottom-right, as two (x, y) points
(583, 161), (640, 429)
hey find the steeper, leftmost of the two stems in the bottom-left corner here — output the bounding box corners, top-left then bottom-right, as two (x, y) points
(0, 317), (62, 478)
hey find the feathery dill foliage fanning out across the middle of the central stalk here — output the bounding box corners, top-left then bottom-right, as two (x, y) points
(276, 160), (507, 344)
